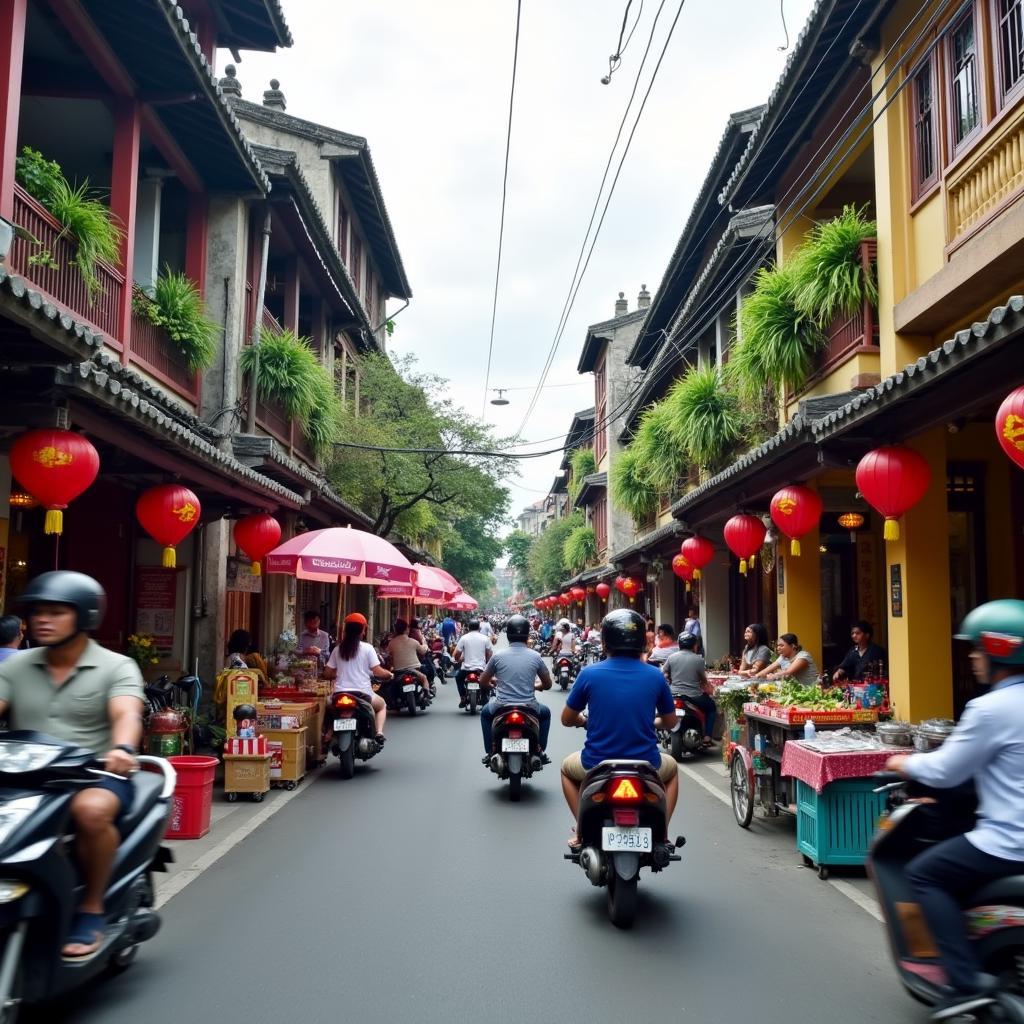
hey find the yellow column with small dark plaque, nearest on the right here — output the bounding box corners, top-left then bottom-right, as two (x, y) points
(885, 426), (953, 722)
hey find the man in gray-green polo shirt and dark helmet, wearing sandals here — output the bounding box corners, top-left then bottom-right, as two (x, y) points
(0, 572), (143, 959)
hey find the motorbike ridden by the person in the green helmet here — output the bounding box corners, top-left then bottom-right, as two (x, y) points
(867, 772), (1024, 1024)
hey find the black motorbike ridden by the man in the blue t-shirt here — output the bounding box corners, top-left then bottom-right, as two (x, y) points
(565, 761), (686, 928)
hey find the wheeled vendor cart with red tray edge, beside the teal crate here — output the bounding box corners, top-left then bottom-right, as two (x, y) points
(729, 703), (879, 828)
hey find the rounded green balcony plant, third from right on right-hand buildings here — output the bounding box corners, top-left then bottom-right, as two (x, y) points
(663, 367), (746, 470)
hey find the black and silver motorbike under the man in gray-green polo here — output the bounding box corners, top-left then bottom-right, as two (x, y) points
(0, 731), (175, 1024)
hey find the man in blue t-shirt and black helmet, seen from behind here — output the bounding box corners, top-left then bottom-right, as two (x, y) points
(562, 608), (679, 820)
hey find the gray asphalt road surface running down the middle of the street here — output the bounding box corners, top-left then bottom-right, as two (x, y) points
(54, 647), (925, 1024)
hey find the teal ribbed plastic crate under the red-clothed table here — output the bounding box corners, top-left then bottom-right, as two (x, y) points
(795, 778), (886, 867)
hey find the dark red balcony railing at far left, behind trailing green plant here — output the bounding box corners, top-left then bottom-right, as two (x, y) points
(8, 184), (125, 348)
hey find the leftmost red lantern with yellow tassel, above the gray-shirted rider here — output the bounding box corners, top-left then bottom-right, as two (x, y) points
(10, 430), (99, 534)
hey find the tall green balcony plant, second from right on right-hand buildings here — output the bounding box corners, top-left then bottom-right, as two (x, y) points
(728, 264), (824, 400)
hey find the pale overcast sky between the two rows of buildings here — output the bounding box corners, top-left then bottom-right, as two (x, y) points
(218, 0), (812, 540)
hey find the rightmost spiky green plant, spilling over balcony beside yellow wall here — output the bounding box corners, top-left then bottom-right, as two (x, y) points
(791, 206), (879, 328)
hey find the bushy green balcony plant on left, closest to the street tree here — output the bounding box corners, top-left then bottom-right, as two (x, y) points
(239, 329), (343, 456)
